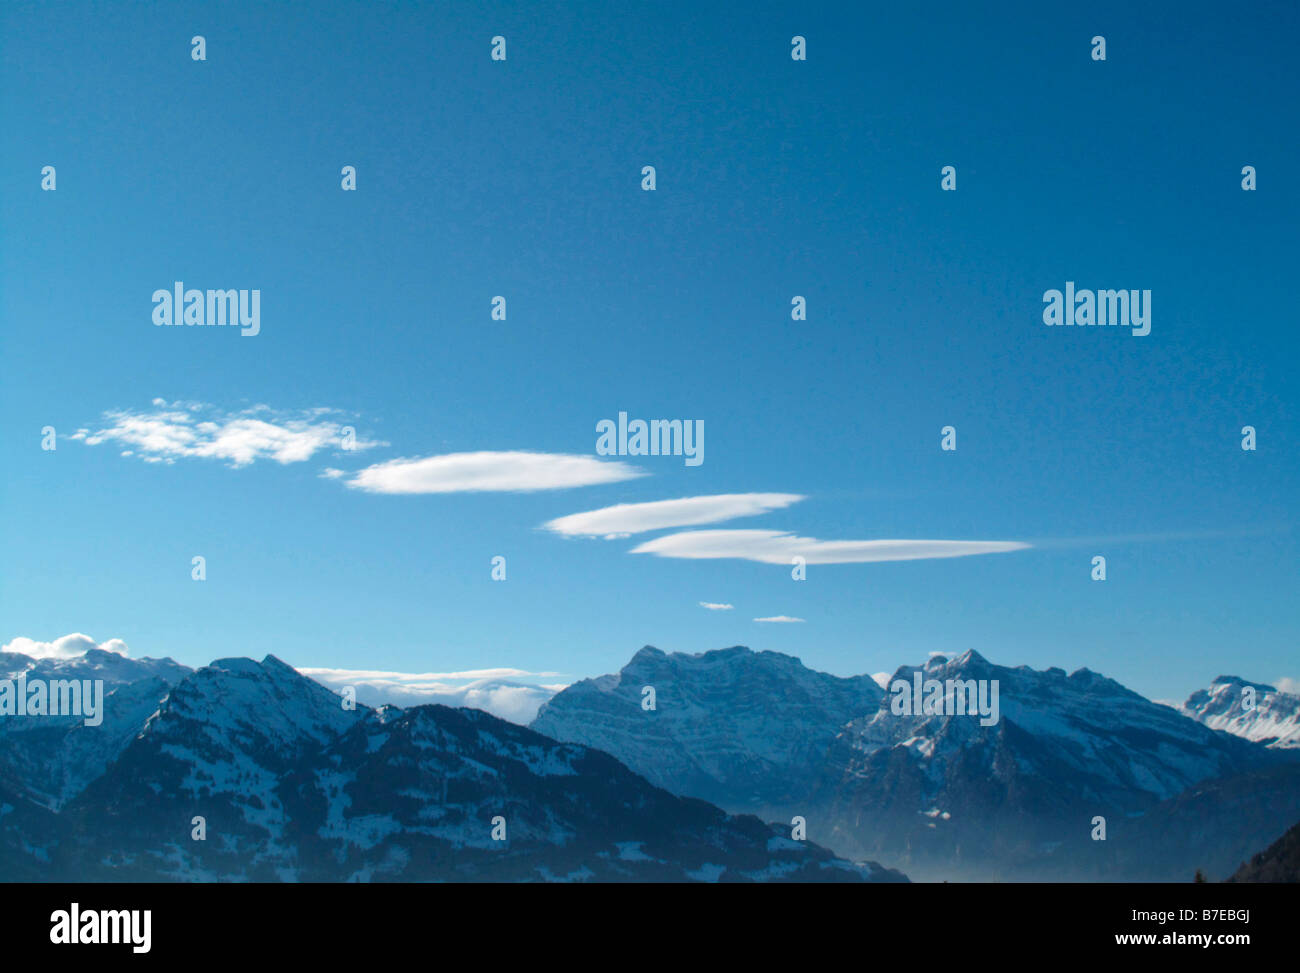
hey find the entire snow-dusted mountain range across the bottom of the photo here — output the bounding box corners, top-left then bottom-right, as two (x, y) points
(0, 637), (1300, 881)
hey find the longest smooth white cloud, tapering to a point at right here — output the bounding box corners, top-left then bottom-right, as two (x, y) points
(632, 531), (1030, 565)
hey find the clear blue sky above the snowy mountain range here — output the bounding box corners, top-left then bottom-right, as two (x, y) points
(0, 3), (1300, 699)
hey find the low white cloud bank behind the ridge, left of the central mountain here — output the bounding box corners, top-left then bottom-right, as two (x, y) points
(298, 667), (564, 725)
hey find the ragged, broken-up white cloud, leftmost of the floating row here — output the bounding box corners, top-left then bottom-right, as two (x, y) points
(69, 398), (387, 467)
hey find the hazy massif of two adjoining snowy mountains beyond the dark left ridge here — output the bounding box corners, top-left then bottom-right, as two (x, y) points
(533, 648), (1300, 881)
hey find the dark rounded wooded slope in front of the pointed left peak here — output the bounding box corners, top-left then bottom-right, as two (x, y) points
(278, 705), (902, 882)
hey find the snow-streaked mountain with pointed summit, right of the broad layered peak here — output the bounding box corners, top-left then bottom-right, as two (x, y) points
(809, 652), (1300, 881)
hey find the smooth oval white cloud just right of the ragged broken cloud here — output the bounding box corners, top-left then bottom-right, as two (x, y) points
(345, 451), (645, 493)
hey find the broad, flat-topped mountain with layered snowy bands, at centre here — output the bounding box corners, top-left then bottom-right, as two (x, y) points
(530, 645), (881, 816)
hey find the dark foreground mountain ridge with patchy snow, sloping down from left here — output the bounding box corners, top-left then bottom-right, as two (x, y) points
(20, 656), (906, 882)
